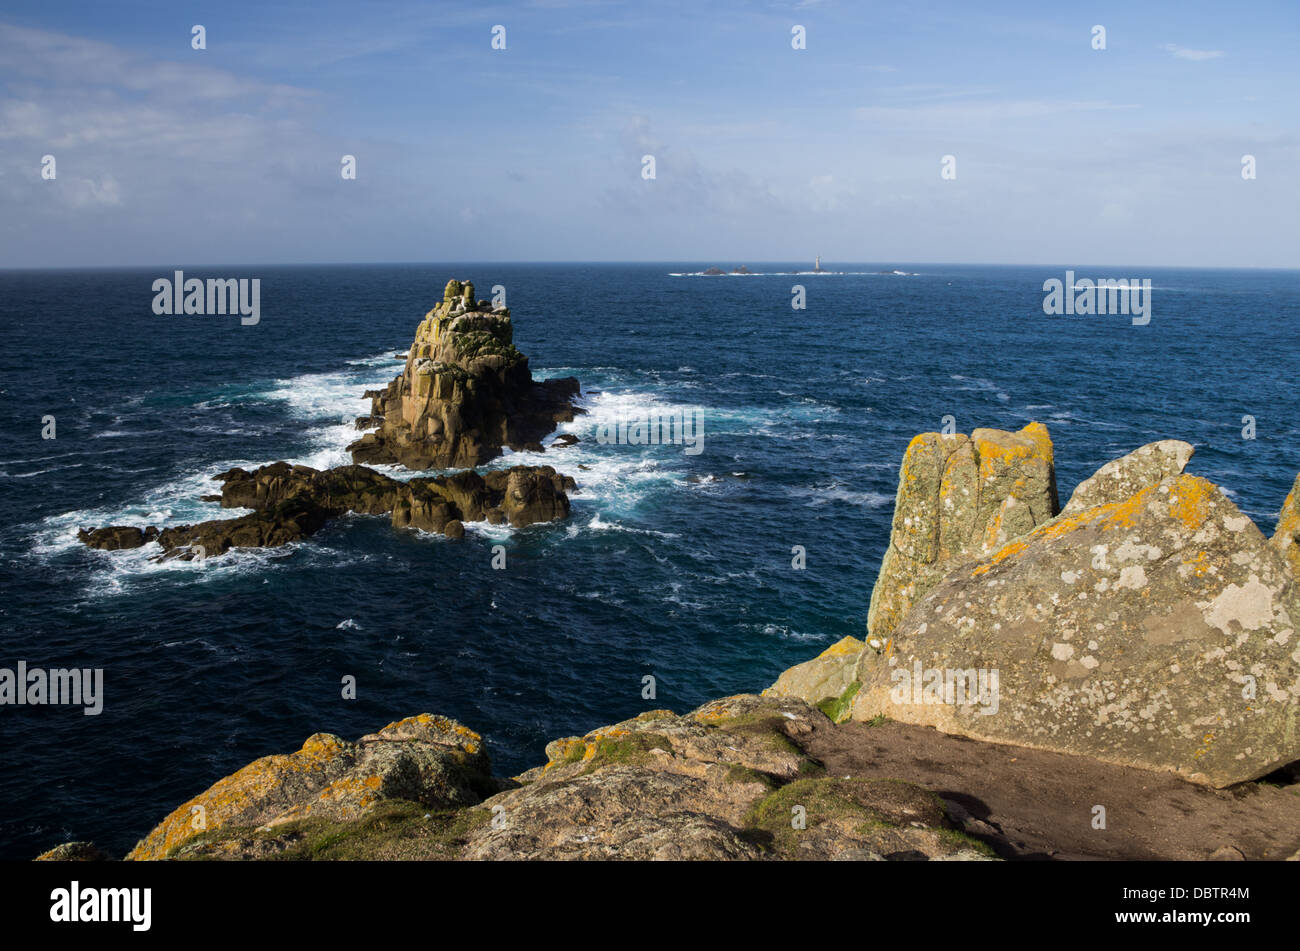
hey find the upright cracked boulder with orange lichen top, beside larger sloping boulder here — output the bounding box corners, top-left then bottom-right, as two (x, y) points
(867, 422), (1058, 638)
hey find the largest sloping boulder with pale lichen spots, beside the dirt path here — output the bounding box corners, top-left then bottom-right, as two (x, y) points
(853, 476), (1300, 787)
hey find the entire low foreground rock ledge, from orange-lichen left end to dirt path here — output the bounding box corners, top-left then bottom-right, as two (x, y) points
(127, 695), (993, 860)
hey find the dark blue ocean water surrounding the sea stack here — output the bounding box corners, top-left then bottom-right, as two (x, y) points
(0, 264), (1300, 859)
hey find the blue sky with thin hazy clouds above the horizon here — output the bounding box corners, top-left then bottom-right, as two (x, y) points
(0, 0), (1300, 268)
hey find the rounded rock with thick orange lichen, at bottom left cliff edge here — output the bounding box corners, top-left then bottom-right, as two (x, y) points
(126, 713), (495, 860)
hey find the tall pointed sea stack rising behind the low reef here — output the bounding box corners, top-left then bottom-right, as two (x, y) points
(348, 281), (581, 469)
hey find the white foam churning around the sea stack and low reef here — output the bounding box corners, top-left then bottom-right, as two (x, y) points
(31, 351), (769, 579)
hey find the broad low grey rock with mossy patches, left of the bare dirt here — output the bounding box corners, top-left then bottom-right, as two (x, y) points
(462, 695), (979, 860)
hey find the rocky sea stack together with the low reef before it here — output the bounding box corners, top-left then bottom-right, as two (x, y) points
(77, 281), (582, 560)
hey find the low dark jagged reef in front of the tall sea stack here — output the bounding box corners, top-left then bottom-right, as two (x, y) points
(78, 463), (576, 560)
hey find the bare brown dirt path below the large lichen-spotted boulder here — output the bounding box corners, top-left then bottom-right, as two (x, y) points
(805, 722), (1300, 860)
